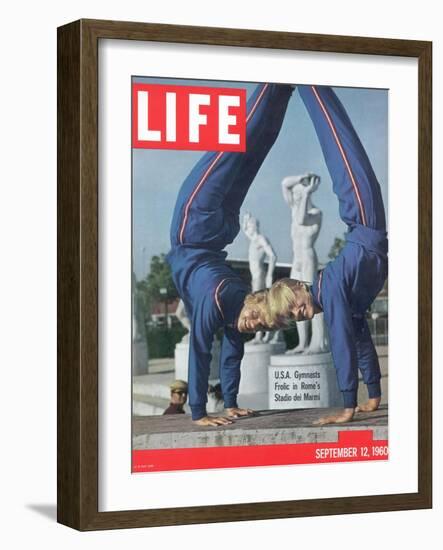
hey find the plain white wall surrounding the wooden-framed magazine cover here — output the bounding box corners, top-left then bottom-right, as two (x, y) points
(0, 0), (443, 550)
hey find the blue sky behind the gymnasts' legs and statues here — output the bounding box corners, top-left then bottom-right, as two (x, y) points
(132, 77), (388, 280)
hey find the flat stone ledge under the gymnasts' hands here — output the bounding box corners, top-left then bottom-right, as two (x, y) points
(133, 405), (388, 449)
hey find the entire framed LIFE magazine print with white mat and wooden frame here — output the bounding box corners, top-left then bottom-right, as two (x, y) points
(58, 20), (432, 530)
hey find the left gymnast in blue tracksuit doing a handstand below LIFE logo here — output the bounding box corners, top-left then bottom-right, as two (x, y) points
(167, 84), (293, 425)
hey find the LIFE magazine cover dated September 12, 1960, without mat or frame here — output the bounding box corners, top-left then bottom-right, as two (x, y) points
(131, 76), (389, 473)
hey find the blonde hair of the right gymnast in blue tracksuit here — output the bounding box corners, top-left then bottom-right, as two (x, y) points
(268, 278), (307, 328)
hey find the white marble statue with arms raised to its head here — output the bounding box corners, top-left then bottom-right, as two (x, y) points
(282, 174), (329, 354)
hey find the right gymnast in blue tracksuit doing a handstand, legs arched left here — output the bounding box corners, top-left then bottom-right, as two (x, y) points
(269, 86), (388, 424)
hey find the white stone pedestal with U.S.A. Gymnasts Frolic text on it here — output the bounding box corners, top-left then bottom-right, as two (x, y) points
(268, 352), (343, 409)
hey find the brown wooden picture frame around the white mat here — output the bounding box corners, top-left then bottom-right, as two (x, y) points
(57, 20), (432, 530)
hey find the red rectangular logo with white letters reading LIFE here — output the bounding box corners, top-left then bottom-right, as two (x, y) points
(132, 83), (250, 152)
